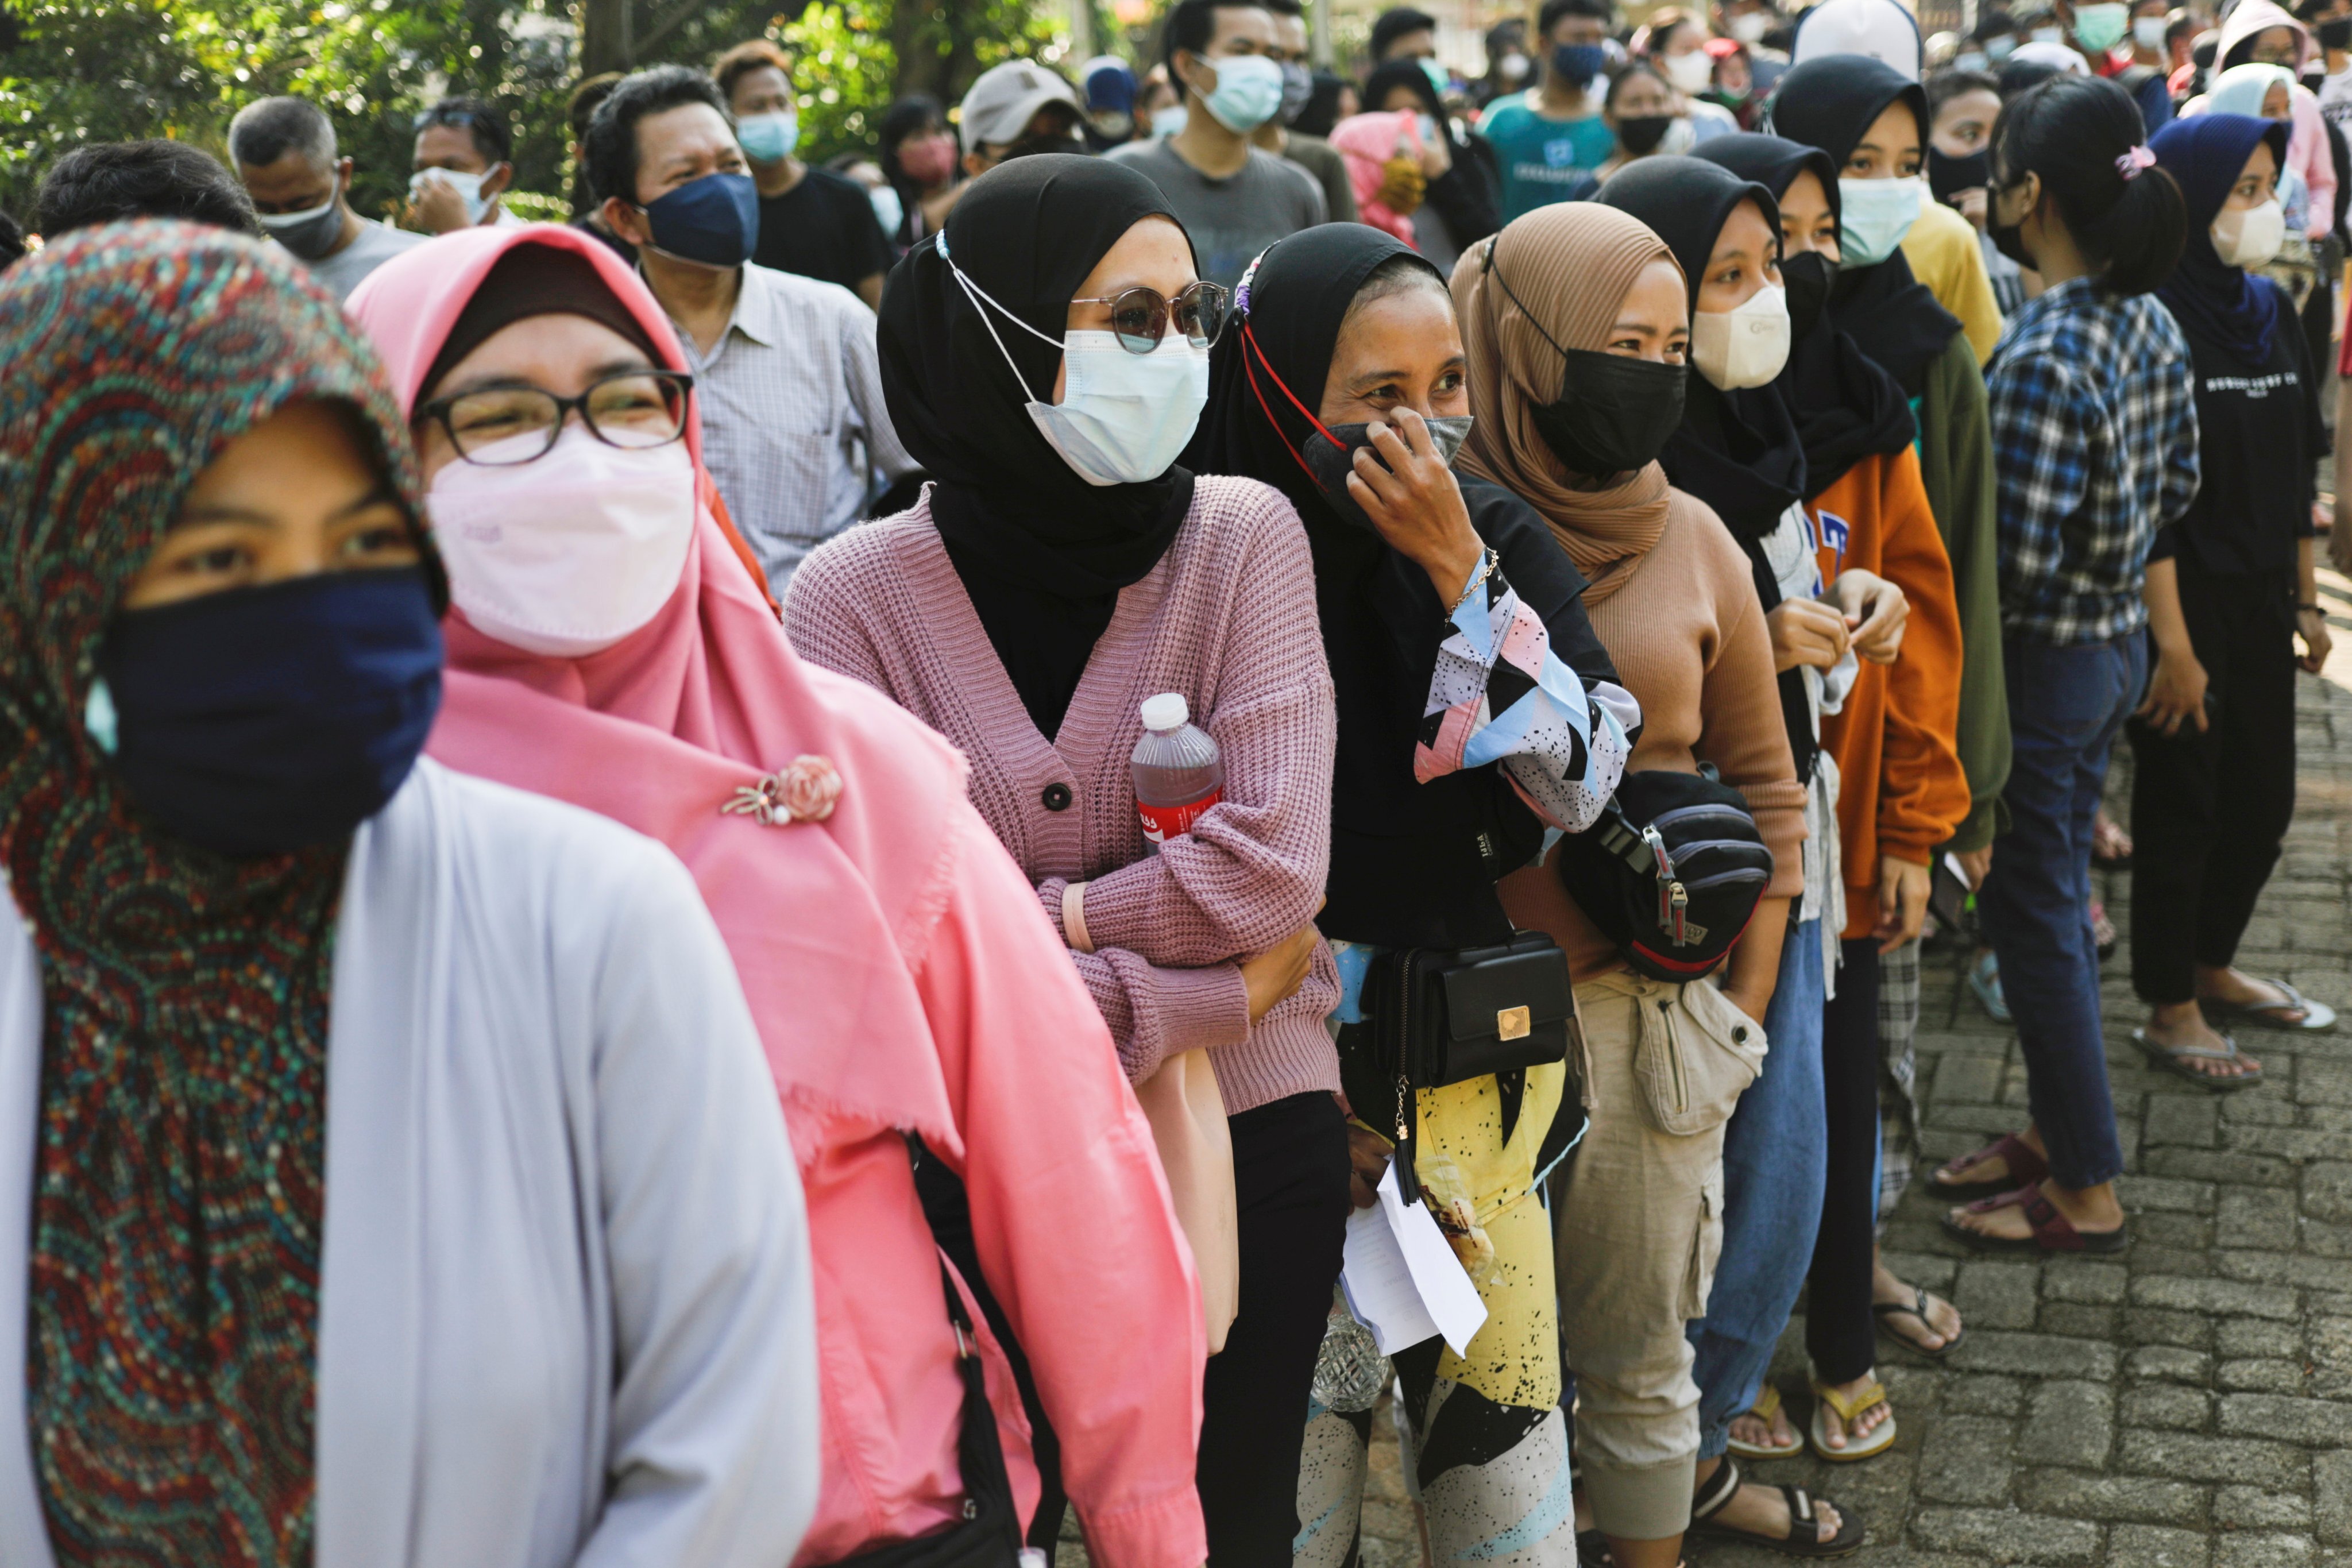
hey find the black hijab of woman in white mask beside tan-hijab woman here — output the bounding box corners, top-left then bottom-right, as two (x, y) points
(1594, 157), (1818, 781)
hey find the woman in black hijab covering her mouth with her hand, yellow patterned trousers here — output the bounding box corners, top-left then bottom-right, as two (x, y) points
(1202, 223), (1639, 1563)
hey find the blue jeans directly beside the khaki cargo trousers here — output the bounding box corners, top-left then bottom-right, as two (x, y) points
(1684, 919), (1830, 1460)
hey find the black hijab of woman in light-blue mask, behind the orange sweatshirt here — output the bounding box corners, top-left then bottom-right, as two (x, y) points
(1768, 54), (1959, 397)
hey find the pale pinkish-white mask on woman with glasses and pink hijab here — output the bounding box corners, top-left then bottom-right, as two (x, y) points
(426, 423), (694, 658)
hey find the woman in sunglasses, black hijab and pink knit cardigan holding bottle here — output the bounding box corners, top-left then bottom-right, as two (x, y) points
(786, 153), (1347, 1563)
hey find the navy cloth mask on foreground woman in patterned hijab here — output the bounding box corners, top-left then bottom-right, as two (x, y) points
(84, 566), (442, 856)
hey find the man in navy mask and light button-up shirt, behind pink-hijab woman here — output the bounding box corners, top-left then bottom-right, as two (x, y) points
(584, 66), (915, 600)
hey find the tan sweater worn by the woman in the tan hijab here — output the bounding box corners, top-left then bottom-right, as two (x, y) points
(1496, 491), (1806, 980)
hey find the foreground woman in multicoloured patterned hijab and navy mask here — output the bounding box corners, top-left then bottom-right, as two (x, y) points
(0, 221), (818, 1568)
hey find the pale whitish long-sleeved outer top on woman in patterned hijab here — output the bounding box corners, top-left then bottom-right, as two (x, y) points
(0, 762), (818, 1568)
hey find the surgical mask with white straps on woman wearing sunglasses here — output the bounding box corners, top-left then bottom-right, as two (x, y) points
(939, 235), (1209, 486)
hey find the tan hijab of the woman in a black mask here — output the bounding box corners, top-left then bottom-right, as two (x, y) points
(1454, 202), (1682, 607)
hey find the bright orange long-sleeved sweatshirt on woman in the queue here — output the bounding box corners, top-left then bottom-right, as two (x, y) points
(1806, 447), (1969, 938)
